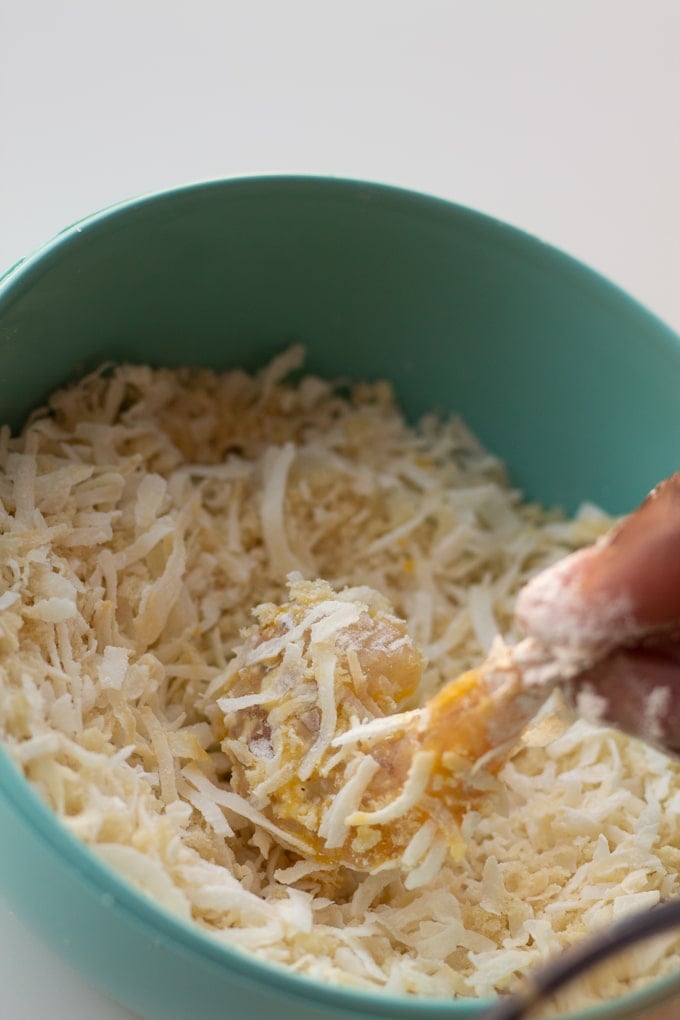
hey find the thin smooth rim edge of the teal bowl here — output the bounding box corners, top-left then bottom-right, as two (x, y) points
(0, 172), (680, 1020)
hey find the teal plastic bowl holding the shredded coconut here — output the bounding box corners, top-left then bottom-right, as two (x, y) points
(0, 176), (680, 1020)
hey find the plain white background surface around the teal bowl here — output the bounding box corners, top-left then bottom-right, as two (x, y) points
(0, 0), (680, 1020)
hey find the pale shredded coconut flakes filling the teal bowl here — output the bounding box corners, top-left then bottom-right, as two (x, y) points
(0, 348), (680, 1008)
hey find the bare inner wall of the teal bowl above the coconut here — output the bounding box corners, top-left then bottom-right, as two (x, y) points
(0, 177), (680, 511)
